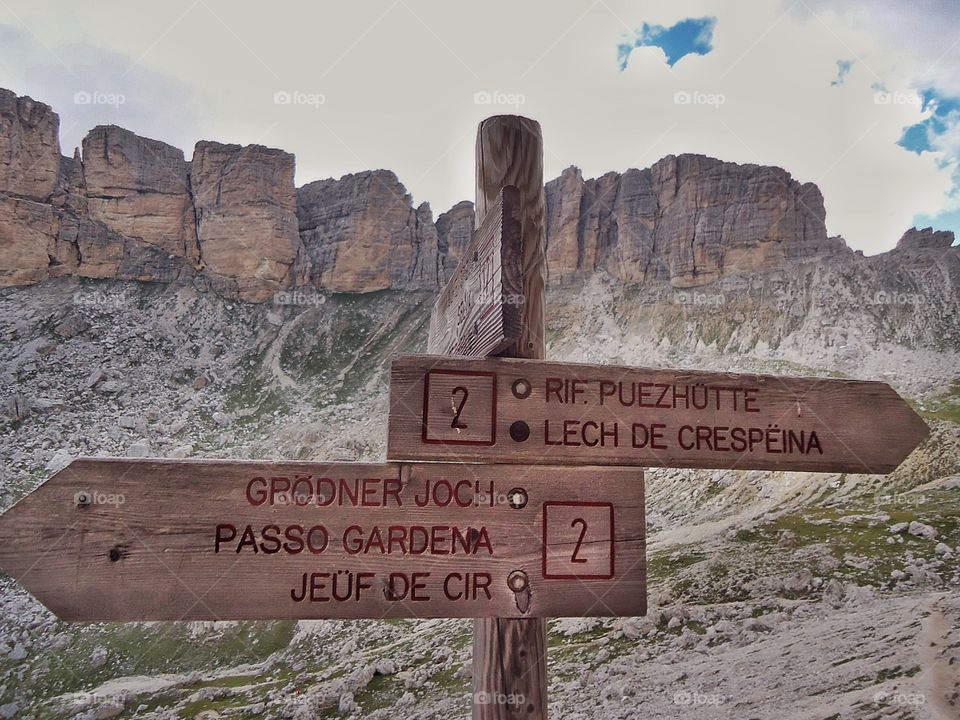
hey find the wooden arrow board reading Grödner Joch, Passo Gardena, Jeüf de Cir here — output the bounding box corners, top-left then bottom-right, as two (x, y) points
(0, 458), (646, 620)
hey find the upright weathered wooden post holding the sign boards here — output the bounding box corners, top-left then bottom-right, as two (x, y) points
(473, 115), (547, 720)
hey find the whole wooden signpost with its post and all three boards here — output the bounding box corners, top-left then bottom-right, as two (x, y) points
(0, 116), (928, 720)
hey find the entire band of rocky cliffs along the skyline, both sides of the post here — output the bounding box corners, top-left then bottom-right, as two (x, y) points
(0, 90), (953, 301)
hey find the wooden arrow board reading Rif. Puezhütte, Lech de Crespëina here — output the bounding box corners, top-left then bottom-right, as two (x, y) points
(387, 355), (929, 473)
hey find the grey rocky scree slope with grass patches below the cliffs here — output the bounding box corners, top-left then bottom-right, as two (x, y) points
(0, 256), (960, 720)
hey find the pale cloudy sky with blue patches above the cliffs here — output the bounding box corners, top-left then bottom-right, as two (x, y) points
(0, 0), (960, 254)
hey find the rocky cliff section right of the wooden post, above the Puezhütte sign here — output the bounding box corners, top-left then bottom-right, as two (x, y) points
(546, 155), (846, 288)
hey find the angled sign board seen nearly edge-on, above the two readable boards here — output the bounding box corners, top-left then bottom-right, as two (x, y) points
(427, 185), (523, 356)
